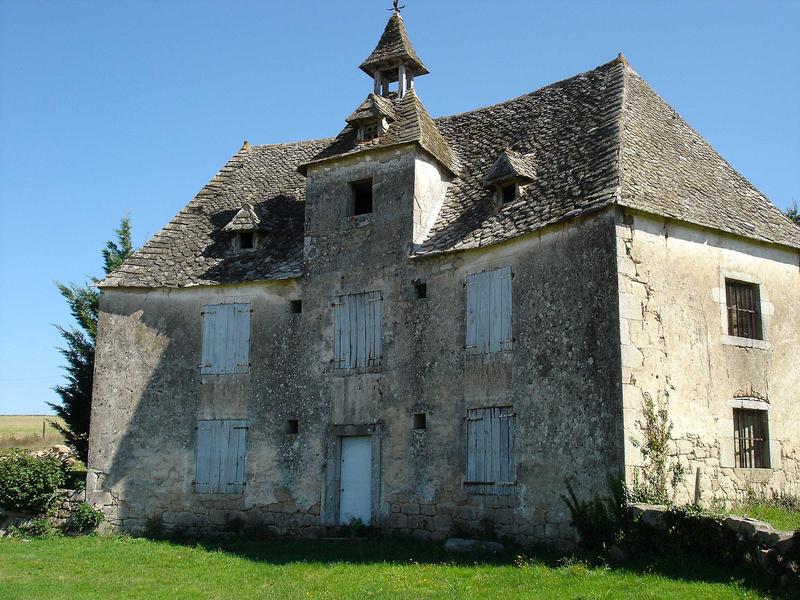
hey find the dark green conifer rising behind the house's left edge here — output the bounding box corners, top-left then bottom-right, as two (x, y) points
(48, 216), (133, 462)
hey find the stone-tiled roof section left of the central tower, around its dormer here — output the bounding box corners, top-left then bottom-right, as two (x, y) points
(99, 139), (331, 287)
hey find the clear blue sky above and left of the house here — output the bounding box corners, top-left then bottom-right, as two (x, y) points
(0, 0), (800, 414)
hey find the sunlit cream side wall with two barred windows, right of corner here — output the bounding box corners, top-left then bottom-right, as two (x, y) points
(617, 212), (800, 505)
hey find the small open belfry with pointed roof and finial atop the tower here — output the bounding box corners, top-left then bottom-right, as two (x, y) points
(359, 0), (429, 98)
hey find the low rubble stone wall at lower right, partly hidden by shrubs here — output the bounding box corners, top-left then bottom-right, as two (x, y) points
(631, 504), (800, 589)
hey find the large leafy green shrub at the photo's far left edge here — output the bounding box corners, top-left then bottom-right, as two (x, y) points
(0, 449), (64, 513)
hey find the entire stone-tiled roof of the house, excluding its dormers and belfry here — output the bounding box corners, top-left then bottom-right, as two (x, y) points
(100, 59), (800, 287)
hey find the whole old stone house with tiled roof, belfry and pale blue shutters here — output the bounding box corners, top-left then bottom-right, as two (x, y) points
(87, 13), (800, 542)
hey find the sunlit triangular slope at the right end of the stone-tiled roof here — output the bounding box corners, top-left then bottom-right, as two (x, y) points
(619, 67), (800, 247)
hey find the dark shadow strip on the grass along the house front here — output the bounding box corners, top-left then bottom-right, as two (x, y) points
(150, 537), (780, 598)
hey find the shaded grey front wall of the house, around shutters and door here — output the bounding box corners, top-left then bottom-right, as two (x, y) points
(87, 149), (624, 542)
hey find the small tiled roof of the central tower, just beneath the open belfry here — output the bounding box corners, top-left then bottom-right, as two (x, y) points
(298, 89), (457, 175)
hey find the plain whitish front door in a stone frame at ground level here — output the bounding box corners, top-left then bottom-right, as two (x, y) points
(339, 436), (372, 525)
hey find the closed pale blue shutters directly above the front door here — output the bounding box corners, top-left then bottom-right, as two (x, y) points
(333, 292), (383, 369)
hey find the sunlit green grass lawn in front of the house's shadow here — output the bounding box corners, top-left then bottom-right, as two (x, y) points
(0, 536), (772, 600)
